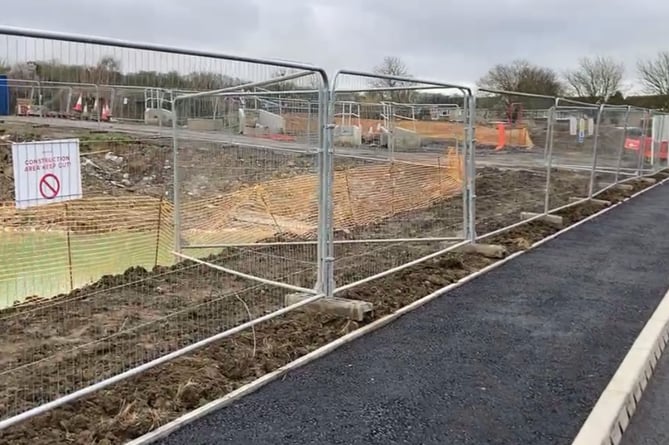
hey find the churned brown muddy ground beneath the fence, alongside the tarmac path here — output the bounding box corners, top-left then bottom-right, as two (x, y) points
(0, 165), (664, 444)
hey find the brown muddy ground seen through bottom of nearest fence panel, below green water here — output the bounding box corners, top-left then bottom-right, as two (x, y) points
(0, 262), (286, 419)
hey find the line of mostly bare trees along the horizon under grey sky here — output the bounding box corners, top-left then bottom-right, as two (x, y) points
(0, 51), (669, 109)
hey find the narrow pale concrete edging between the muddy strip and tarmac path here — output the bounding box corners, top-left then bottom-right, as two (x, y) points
(126, 177), (669, 445)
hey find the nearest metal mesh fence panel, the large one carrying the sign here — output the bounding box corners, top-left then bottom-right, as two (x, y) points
(0, 27), (329, 428)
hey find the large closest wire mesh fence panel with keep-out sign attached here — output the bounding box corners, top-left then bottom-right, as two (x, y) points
(0, 27), (331, 429)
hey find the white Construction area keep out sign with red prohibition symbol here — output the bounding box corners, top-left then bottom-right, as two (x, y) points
(12, 139), (82, 209)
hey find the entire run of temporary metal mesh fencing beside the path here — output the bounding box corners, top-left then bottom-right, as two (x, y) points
(0, 26), (669, 429)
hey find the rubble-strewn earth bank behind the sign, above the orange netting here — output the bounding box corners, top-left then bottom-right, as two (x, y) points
(0, 122), (334, 201)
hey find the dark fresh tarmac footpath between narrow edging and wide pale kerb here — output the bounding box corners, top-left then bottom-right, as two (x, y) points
(160, 183), (669, 445)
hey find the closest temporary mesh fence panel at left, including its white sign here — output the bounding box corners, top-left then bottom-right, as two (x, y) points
(0, 26), (327, 427)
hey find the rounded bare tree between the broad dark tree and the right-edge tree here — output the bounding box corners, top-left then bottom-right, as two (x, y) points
(565, 56), (625, 102)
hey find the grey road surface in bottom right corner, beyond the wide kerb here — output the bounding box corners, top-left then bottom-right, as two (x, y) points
(621, 340), (669, 445)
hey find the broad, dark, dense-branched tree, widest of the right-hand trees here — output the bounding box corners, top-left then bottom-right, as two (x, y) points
(478, 60), (564, 96)
